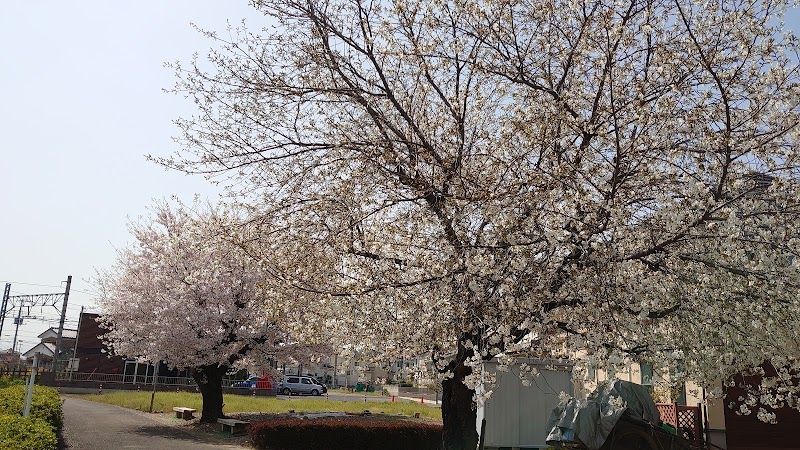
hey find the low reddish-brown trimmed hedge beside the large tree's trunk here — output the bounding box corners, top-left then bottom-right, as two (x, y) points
(250, 417), (442, 450)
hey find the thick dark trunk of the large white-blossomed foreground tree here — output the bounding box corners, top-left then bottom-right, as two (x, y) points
(442, 343), (478, 450)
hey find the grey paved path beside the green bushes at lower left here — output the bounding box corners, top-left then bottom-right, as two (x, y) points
(64, 397), (247, 450)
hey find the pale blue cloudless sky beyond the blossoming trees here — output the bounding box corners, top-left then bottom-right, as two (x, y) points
(0, 4), (800, 356)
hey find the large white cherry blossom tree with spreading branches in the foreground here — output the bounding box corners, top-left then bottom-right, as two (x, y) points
(157, 0), (800, 449)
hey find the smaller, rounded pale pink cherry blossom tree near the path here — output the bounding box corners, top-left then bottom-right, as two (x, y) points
(97, 204), (307, 422)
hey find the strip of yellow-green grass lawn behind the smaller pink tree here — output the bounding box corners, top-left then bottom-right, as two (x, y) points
(67, 391), (442, 421)
